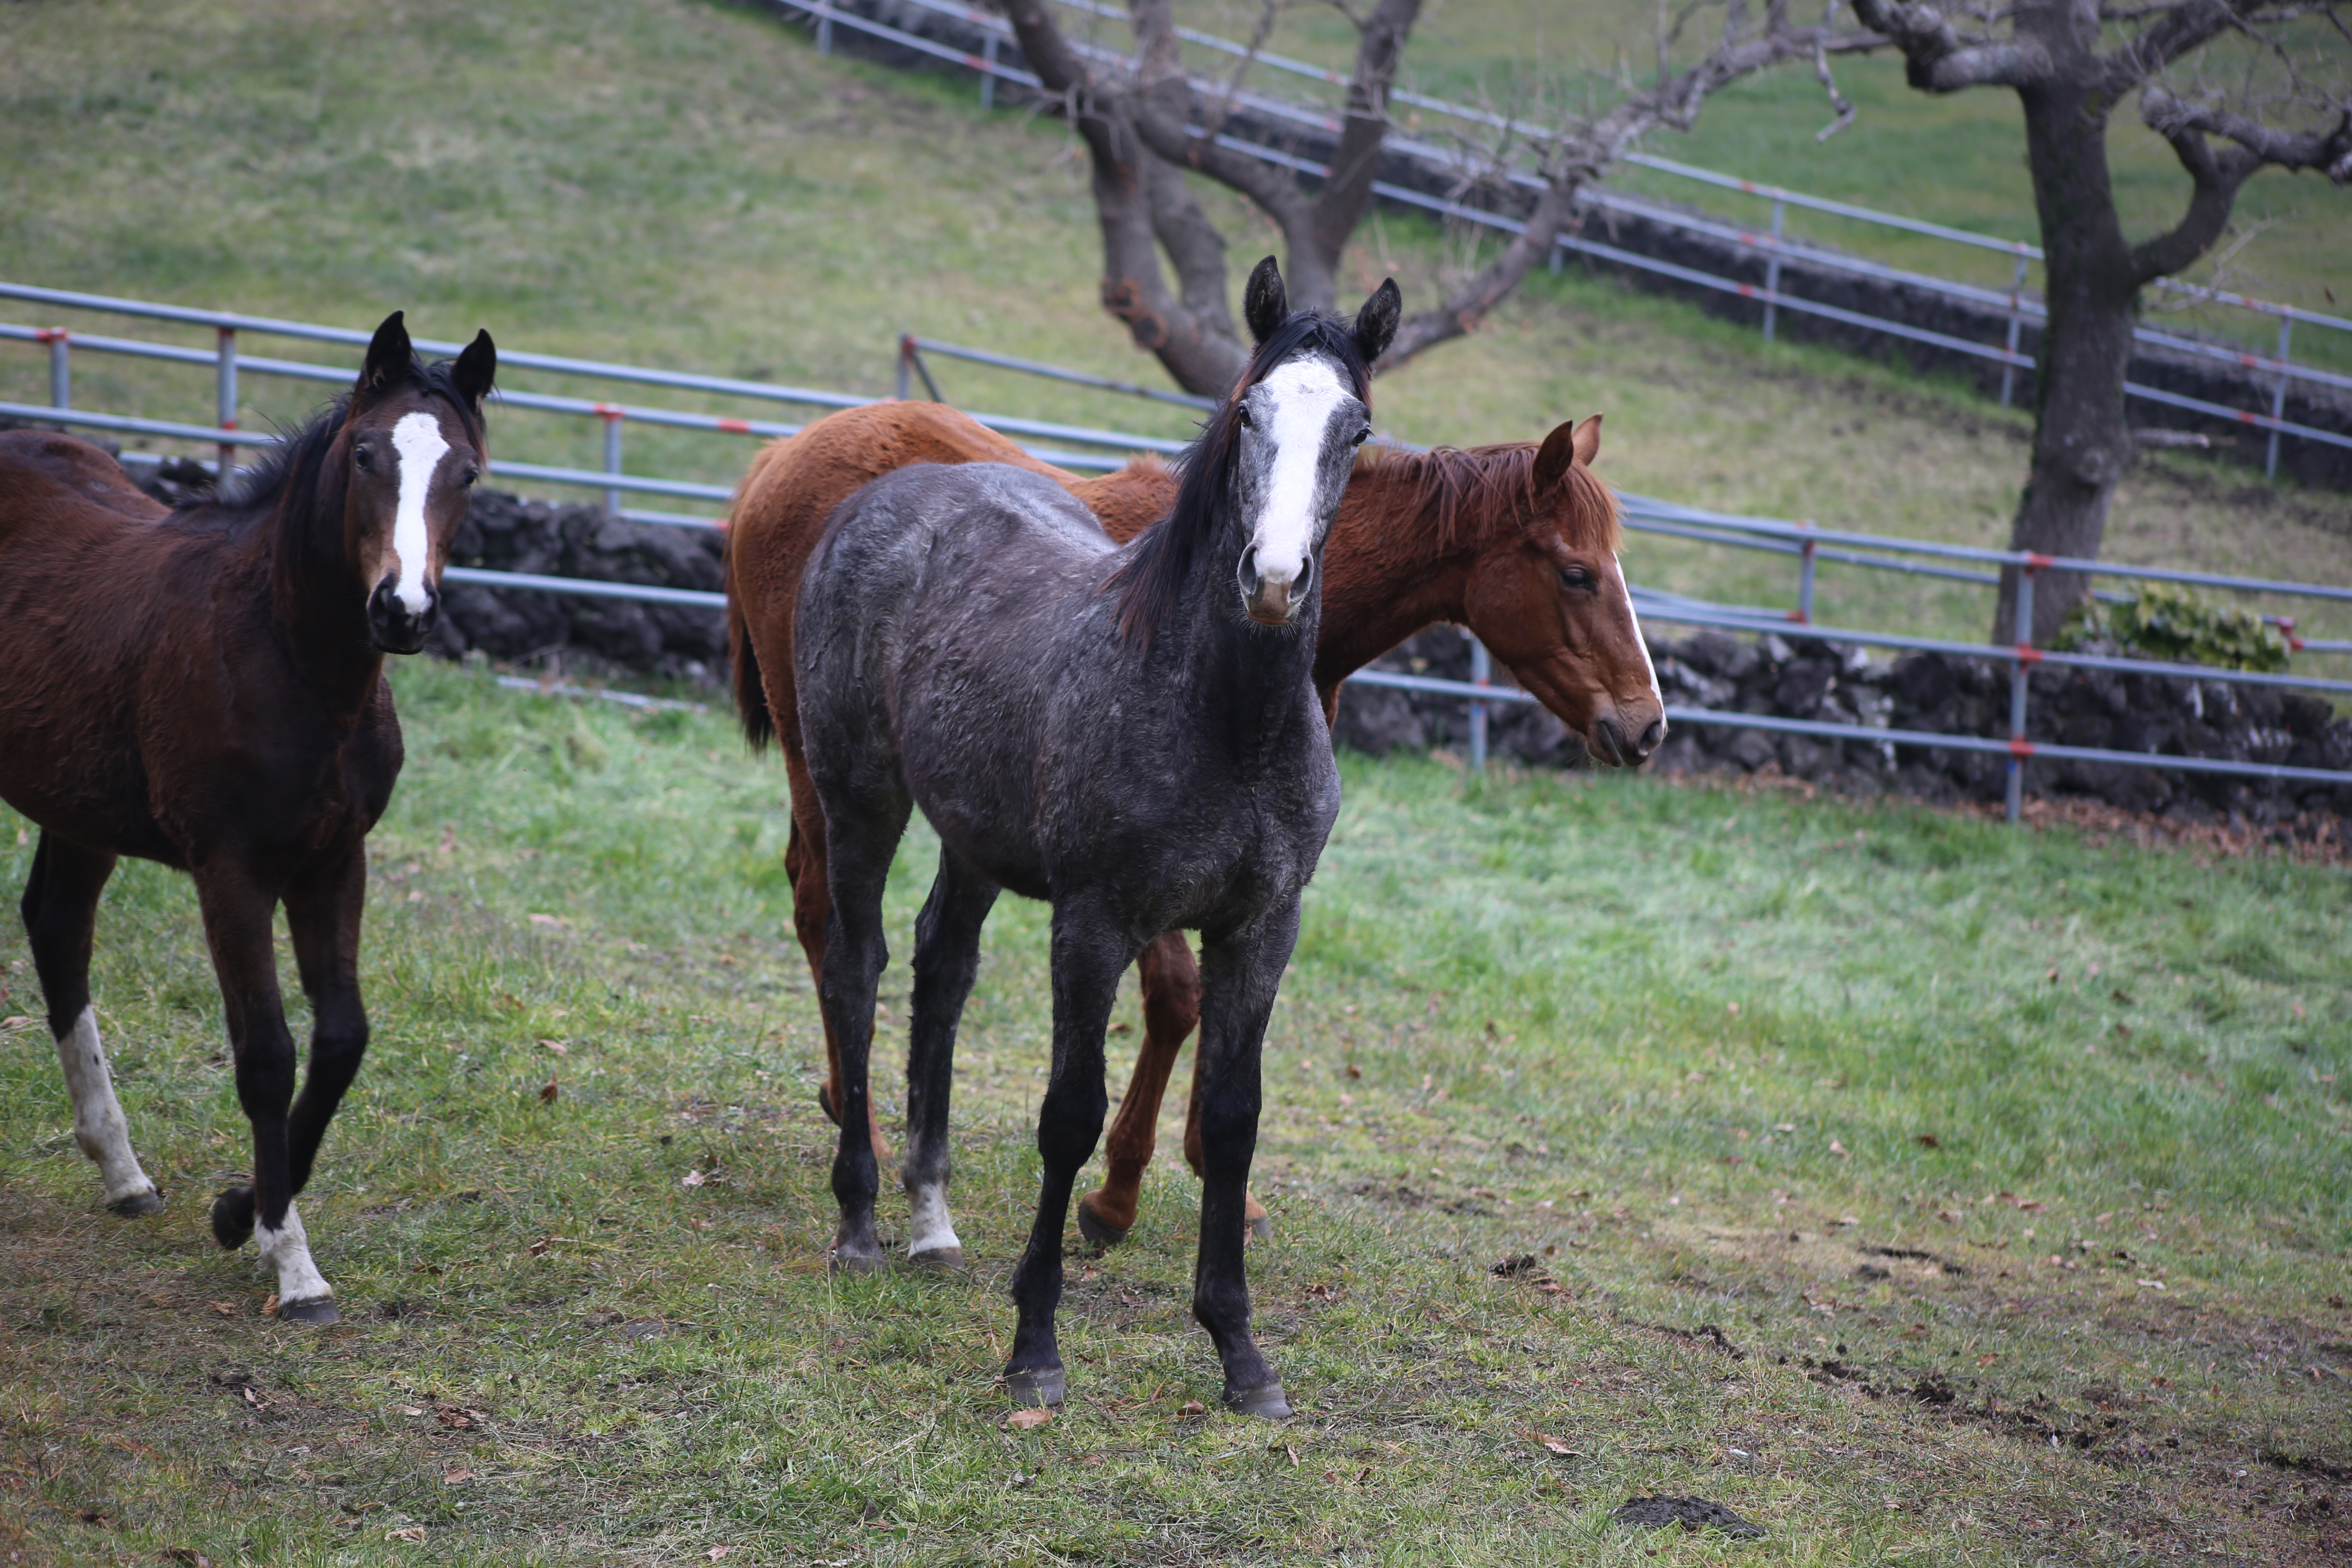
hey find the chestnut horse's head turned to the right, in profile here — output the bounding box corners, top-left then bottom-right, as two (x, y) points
(1463, 414), (1665, 766)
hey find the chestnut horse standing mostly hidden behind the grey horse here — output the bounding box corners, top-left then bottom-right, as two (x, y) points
(727, 402), (1665, 1244)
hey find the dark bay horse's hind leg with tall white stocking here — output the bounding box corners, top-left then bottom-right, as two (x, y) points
(21, 832), (162, 1220)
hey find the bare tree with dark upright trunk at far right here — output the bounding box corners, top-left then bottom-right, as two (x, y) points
(1853, 0), (2352, 642)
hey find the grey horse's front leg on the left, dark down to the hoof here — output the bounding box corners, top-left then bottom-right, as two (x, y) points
(1004, 898), (1138, 1406)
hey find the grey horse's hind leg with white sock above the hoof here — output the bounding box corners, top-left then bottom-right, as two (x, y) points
(898, 849), (997, 1270)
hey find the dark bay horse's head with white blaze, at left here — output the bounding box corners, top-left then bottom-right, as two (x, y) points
(341, 310), (499, 653)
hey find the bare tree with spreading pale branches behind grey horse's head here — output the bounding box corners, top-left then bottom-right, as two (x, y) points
(997, 0), (1884, 397)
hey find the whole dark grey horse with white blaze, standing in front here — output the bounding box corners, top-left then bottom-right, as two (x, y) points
(793, 256), (1397, 1415)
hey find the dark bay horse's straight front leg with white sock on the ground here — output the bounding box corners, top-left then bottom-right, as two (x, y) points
(195, 863), (336, 1323)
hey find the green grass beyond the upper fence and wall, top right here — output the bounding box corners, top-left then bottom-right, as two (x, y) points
(1181, 0), (2352, 352)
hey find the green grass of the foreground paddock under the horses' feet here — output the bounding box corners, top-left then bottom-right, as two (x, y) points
(0, 663), (2352, 1563)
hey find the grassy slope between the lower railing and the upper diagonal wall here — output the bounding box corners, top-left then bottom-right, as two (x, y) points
(0, 0), (2352, 653)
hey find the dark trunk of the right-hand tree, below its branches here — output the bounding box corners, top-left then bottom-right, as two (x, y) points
(1992, 80), (2140, 644)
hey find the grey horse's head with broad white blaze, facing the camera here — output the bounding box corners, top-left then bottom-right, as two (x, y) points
(1211, 256), (1399, 625)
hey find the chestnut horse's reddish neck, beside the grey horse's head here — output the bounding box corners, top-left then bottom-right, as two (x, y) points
(1315, 463), (1486, 689)
